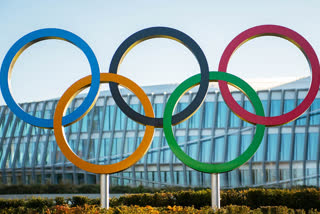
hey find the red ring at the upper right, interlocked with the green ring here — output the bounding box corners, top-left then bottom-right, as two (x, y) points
(218, 25), (320, 126)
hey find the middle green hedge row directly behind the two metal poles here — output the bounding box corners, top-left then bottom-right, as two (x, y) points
(0, 188), (320, 211)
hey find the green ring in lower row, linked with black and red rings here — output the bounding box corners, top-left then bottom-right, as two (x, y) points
(163, 72), (265, 173)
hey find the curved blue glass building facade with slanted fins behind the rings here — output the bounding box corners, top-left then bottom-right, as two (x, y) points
(0, 79), (320, 188)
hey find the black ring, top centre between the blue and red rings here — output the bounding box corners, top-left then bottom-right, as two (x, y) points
(109, 27), (209, 127)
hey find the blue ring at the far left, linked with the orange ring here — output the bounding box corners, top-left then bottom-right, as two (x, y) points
(0, 28), (100, 128)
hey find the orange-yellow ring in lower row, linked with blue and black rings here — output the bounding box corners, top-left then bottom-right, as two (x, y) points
(53, 73), (154, 174)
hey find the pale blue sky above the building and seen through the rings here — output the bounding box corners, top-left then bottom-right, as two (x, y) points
(0, 0), (320, 105)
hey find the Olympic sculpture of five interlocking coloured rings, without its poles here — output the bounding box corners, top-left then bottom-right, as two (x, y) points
(0, 25), (320, 174)
